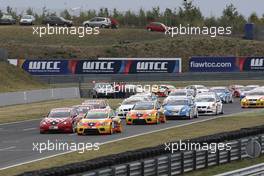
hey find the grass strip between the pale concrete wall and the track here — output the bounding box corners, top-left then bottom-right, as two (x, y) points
(0, 99), (121, 123)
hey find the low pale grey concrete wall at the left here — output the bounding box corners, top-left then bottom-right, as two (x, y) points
(0, 87), (80, 106)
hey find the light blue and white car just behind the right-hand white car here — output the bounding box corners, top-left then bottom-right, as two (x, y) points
(210, 87), (234, 103)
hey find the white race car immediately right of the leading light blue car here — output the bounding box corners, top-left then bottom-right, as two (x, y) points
(195, 93), (224, 115)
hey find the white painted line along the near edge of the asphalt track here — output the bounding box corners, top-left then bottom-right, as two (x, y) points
(0, 110), (258, 171)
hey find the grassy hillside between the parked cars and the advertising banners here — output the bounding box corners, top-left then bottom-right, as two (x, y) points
(0, 26), (264, 71)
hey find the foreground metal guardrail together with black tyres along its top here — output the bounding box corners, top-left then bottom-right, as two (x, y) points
(17, 125), (264, 176)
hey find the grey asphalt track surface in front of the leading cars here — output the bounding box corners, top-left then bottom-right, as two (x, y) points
(0, 100), (252, 170)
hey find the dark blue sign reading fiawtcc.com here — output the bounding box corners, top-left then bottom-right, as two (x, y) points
(189, 57), (240, 72)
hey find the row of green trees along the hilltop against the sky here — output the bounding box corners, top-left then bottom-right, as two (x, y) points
(0, 2), (264, 32)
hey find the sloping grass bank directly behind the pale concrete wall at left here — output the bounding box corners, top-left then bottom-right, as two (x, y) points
(0, 62), (48, 92)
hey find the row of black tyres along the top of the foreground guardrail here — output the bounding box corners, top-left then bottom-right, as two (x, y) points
(18, 125), (264, 176)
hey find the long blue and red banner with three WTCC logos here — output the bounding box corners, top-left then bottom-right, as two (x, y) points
(18, 58), (181, 75)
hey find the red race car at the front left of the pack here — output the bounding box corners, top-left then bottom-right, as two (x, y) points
(40, 108), (78, 134)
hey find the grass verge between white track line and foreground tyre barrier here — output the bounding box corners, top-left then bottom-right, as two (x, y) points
(0, 110), (264, 175)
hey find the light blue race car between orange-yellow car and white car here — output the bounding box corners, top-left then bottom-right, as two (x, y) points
(163, 97), (198, 120)
